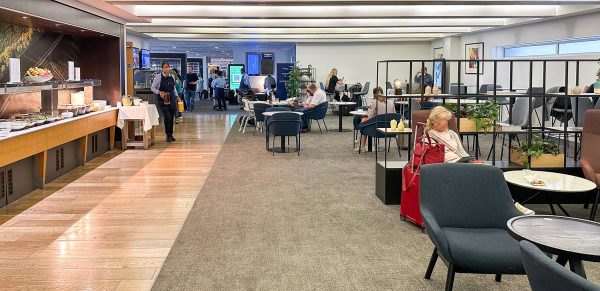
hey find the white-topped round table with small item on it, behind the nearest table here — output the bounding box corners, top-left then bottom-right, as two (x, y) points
(504, 170), (598, 219)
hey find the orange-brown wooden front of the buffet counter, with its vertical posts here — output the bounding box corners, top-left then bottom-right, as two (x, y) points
(0, 108), (119, 188)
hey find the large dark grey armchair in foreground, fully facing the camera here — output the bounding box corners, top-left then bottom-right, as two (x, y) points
(420, 164), (525, 291)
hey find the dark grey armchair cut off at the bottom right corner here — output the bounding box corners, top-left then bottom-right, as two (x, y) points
(519, 240), (600, 291)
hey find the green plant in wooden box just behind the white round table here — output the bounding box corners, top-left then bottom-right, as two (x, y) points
(510, 136), (564, 168)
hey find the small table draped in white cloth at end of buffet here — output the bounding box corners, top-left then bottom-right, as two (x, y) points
(117, 104), (159, 150)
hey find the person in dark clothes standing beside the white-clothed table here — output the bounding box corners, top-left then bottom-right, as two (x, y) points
(151, 61), (180, 142)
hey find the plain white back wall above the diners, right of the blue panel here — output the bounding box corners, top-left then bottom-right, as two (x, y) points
(296, 42), (433, 95)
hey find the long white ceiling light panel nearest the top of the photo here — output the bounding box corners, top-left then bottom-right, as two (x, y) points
(119, 5), (557, 18)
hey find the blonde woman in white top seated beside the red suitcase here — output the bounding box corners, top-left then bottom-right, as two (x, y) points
(423, 106), (474, 163)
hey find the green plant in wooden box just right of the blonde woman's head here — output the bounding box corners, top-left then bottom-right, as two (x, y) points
(459, 101), (500, 133)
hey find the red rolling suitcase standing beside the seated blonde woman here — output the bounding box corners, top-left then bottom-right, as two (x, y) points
(400, 123), (445, 228)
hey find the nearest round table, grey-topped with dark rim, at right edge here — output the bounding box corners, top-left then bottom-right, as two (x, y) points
(506, 215), (600, 278)
